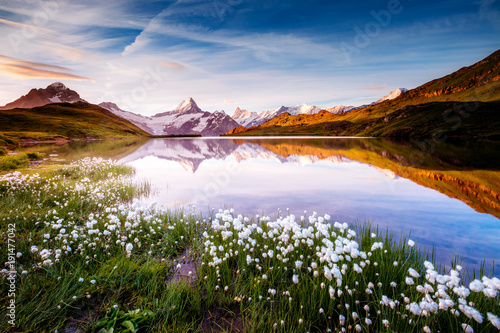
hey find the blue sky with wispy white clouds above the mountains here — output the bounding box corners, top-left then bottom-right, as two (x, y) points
(0, 0), (500, 115)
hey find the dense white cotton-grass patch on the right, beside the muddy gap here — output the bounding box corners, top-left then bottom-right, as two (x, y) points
(201, 210), (500, 332)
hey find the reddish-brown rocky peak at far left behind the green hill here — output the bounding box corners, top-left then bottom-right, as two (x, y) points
(0, 82), (86, 110)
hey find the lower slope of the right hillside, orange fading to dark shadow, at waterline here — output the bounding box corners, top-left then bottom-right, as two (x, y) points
(227, 102), (500, 140)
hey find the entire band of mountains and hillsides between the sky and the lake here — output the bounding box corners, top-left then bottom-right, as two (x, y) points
(0, 50), (500, 143)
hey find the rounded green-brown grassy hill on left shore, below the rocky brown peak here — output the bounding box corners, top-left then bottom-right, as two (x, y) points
(0, 102), (149, 145)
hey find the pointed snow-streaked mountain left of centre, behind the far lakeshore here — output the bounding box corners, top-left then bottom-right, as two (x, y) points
(99, 97), (238, 136)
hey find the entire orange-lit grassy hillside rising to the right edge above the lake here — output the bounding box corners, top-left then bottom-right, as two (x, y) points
(227, 50), (500, 139)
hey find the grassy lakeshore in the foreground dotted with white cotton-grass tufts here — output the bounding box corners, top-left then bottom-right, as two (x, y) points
(0, 159), (500, 332)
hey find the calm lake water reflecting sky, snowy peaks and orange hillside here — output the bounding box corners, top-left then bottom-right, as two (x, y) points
(29, 138), (500, 276)
